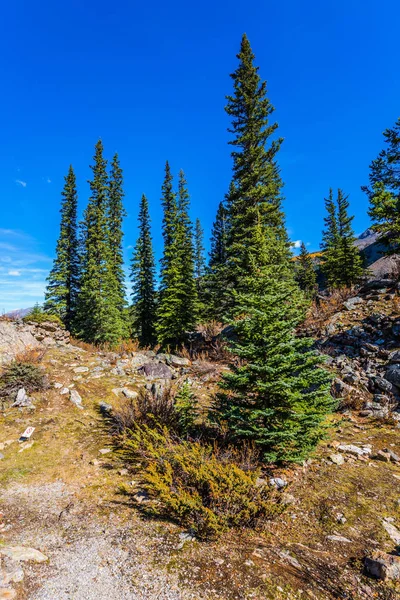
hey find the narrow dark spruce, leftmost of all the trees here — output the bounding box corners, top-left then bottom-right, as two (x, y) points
(44, 165), (79, 329)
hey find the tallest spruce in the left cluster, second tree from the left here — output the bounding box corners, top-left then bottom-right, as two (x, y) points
(76, 140), (127, 344)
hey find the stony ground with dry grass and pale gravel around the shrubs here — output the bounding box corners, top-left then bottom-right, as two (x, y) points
(0, 312), (400, 600)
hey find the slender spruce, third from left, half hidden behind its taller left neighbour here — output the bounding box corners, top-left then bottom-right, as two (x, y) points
(108, 154), (126, 310)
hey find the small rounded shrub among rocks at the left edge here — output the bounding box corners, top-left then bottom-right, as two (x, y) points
(0, 361), (49, 398)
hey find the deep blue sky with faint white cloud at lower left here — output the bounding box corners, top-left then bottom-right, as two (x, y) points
(0, 0), (400, 311)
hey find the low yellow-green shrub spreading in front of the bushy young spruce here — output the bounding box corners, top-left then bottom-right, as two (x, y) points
(122, 424), (280, 539)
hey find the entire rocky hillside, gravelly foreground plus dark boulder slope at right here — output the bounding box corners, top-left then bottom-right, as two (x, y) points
(0, 290), (400, 600)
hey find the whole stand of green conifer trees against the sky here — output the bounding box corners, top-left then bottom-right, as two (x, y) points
(44, 35), (400, 460)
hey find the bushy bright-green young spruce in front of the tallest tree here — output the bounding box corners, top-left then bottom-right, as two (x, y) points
(213, 226), (334, 461)
